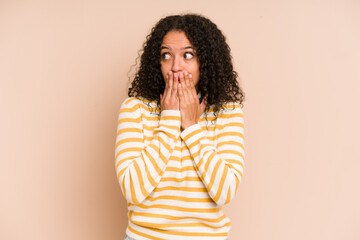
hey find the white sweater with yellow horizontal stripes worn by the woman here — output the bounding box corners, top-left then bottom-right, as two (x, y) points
(115, 97), (245, 240)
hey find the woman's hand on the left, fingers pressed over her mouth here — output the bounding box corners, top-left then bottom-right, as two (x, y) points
(160, 71), (179, 111)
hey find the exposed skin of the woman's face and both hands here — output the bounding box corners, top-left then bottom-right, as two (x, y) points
(160, 31), (206, 129)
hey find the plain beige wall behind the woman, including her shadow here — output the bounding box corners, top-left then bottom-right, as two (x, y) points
(0, 0), (360, 240)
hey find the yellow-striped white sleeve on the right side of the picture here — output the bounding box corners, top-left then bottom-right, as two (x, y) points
(180, 104), (245, 206)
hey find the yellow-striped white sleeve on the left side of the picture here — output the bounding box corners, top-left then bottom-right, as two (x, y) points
(115, 98), (180, 205)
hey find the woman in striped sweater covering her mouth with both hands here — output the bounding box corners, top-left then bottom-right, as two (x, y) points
(115, 14), (244, 240)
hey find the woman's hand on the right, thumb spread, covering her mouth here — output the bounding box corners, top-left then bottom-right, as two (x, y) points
(178, 72), (206, 129)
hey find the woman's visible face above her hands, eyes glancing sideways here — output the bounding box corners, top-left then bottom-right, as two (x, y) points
(160, 31), (200, 86)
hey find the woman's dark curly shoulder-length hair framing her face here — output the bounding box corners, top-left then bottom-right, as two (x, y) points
(128, 14), (244, 117)
